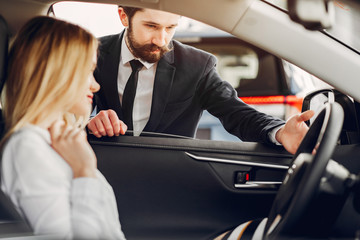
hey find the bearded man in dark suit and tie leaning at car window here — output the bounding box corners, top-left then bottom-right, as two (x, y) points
(88, 7), (313, 153)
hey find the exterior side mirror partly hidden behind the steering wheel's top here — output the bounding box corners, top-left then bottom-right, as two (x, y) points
(301, 88), (335, 126)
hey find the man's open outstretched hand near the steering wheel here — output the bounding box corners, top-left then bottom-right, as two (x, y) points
(275, 110), (315, 154)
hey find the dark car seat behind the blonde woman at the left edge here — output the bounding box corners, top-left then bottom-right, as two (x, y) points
(0, 15), (32, 238)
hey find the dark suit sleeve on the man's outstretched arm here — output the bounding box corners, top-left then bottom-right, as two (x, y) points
(197, 55), (285, 144)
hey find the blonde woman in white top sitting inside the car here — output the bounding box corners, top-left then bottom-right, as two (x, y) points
(1, 17), (125, 239)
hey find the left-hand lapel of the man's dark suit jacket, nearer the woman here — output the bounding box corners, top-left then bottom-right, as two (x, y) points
(101, 32), (124, 119)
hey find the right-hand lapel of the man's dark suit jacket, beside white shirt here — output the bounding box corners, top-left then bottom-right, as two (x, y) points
(144, 47), (176, 132)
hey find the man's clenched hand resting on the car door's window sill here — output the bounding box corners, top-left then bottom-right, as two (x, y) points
(87, 109), (127, 138)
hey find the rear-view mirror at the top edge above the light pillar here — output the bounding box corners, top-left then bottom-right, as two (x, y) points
(288, 0), (335, 30)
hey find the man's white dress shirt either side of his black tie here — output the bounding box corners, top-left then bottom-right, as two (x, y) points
(117, 31), (157, 136)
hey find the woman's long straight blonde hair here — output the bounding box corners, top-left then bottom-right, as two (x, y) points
(3, 16), (98, 144)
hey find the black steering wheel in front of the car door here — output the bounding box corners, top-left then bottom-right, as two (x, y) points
(264, 102), (344, 239)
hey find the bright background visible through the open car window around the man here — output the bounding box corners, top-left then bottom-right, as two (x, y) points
(53, 0), (326, 141)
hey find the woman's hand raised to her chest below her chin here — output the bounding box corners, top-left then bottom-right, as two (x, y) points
(49, 121), (97, 178)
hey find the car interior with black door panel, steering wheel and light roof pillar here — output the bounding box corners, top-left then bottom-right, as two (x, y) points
(0, 0), (360, 240)
